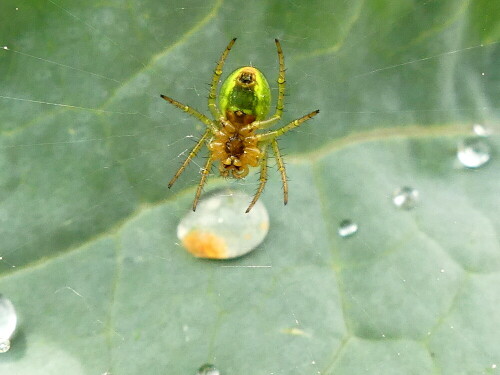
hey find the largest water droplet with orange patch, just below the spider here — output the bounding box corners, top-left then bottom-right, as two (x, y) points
(177, 190), (269, 259)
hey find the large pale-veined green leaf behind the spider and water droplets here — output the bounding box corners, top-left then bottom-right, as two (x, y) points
(0, 0), (500, 375)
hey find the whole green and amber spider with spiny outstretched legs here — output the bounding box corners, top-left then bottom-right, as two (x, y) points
(161, 38), (319, 213)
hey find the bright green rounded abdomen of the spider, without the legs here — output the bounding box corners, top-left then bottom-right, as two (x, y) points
(219, 66), (271, 120)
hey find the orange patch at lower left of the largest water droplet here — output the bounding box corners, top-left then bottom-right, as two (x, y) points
(182, 230), (228, 259)
